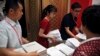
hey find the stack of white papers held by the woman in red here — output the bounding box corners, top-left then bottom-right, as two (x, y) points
(47, 29), (62, 43)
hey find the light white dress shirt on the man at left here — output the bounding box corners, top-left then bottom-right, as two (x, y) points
(0, 17), (22, 48)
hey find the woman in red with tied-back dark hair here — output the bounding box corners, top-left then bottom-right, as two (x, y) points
(37, 5), (57, 48)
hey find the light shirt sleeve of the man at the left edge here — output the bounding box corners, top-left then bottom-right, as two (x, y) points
(0, 29), (8, 48)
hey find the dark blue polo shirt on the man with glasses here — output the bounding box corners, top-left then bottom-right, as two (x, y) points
(60, 13), (77, 40)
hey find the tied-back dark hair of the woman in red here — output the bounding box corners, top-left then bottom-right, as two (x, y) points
(41, 5), (57, 19)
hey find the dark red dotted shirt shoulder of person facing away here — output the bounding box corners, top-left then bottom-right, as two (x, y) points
(73, 40), (100, 56)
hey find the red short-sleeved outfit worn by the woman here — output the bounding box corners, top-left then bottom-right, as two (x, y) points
(37, 17), (50, 48)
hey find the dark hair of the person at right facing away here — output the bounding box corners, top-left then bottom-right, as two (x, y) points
(82, 5), (100, 34)
